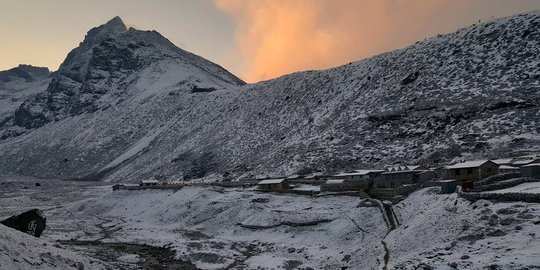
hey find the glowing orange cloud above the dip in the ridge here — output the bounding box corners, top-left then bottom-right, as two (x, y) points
(214, 0), (532, 82)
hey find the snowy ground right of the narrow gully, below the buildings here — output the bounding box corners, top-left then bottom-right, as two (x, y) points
(385, 188), (540, 269)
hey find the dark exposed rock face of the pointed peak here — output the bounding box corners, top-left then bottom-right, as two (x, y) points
(14, 17), (243, 129)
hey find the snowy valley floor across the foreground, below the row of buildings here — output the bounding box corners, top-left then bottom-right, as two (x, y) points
(0, 177), (540, 269)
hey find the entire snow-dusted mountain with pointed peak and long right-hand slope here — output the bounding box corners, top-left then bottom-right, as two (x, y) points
(0, 11), (540, 181)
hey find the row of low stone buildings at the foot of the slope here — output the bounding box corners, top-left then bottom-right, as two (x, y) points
(258, 157), (540, 197)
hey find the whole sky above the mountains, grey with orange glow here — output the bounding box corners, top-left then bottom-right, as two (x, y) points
(0, 0), (540, 82)
